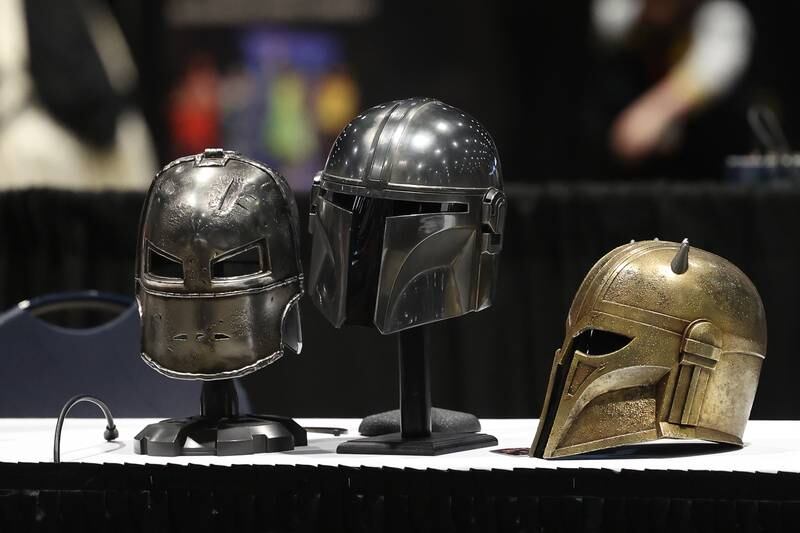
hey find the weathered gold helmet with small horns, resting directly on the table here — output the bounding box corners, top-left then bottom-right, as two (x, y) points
(531, 240), (767, 458)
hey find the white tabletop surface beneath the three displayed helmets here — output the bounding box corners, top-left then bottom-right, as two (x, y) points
(0, 418), (800, 472)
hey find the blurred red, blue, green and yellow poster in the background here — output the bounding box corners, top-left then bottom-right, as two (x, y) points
(169, 29), (359, 190)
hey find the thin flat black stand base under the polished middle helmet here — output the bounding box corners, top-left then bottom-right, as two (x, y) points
(336, 433), (497, 455)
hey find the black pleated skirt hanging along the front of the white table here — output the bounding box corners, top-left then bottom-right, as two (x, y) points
(0, 463), (800, 533)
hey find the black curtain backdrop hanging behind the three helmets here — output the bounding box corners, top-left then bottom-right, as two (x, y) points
(0, 184), (800, 419)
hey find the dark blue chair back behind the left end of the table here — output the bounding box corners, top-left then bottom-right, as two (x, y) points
(0, 291), (200, 418)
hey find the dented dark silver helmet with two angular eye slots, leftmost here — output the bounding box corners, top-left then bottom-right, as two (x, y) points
(136, 149), (303, 380)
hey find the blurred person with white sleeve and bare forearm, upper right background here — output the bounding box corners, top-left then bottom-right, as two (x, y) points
(584, 0), (754, 179)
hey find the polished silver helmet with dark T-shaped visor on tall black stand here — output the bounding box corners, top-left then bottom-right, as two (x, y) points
(309, 98), (505, 334)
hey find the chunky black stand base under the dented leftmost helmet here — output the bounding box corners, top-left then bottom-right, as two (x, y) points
(134, 415), (307, 457)
